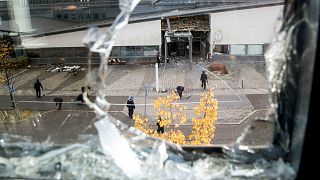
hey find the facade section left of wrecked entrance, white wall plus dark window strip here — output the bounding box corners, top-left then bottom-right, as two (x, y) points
(22, 20), (161, 64)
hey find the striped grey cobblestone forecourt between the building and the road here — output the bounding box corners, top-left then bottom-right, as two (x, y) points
(0, 63), (268, 96)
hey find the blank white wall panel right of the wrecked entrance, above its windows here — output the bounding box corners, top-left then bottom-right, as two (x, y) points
(210, 5), (283, 44)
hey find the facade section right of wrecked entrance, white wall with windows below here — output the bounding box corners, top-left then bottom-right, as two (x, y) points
(210, 5), (282, 55)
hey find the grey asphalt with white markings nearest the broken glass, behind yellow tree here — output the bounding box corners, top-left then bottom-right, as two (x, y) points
(0, 104), (273, 145)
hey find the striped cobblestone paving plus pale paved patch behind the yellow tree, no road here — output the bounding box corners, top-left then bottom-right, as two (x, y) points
(2, 62), (268, 123)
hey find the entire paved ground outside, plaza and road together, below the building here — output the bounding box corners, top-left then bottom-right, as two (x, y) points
(0, 62), (268, 144)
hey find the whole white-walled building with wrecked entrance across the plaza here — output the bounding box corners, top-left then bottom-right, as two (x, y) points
(0, 0), (283, 63)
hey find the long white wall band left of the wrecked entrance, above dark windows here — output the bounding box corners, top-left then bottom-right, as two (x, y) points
(22, 20), (161, 48)
